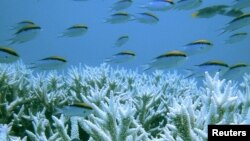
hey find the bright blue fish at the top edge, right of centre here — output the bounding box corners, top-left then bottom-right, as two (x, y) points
(141, 0), (174, 11)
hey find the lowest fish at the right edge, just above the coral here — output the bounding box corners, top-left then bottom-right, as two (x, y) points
(223, 63), (250, 80)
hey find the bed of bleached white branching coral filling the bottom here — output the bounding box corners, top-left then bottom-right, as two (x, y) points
(0, 62), (250, 141)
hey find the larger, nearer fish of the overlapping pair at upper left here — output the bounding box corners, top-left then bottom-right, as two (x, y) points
(8, 24), (41, 45)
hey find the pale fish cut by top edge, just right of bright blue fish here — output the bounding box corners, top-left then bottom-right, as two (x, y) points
(175, 0), (202, 10)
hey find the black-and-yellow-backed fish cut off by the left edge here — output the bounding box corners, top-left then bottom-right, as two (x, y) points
(0, 46), (20, 63)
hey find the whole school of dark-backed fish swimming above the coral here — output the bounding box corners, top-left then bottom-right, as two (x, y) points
(0, 0), (250, 79)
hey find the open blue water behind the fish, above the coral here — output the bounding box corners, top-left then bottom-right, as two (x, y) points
(0, 0), (250, 72)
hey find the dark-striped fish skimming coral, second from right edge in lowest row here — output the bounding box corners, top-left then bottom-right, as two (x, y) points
(185, 60), (229, 78)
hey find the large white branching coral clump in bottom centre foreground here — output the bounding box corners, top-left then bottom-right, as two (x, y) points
(80, 94), (147, 141)
